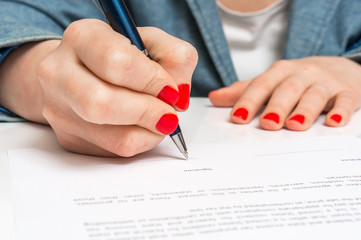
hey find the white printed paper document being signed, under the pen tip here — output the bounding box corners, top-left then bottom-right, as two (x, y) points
(9, 136), (361, 240)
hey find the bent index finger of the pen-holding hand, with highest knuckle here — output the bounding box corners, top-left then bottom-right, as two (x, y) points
(62, 20), (179, 105)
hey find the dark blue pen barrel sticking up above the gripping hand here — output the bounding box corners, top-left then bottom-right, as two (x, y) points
(99, 0), (145, 52)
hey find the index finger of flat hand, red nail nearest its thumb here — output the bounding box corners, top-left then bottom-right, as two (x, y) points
(231, 60), (293, 123)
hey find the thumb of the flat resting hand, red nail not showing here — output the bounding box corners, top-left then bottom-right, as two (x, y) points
(208, 81), (250, 107)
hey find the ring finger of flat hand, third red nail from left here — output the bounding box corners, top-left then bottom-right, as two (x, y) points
(286, 85), (334, 131)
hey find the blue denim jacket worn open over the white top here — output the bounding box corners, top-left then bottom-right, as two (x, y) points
(0, 0), (361, 120)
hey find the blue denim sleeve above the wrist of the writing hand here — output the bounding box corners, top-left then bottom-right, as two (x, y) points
(0, 0), (102, 48)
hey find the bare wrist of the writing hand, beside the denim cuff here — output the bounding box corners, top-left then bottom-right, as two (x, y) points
(0, 40), (57, 123)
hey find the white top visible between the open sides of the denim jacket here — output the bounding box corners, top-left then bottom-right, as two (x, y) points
(217, 0), (289, 81)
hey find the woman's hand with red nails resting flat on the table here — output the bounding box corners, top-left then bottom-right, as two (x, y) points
(209, 57), (361, 131)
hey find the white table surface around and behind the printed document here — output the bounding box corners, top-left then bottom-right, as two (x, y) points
(0, 98), (361, 240)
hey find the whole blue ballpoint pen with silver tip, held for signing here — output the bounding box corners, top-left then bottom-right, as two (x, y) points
(98, 0), (188, 159)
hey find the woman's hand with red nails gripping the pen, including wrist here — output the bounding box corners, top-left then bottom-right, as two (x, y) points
(0, 20), (197, 156)
